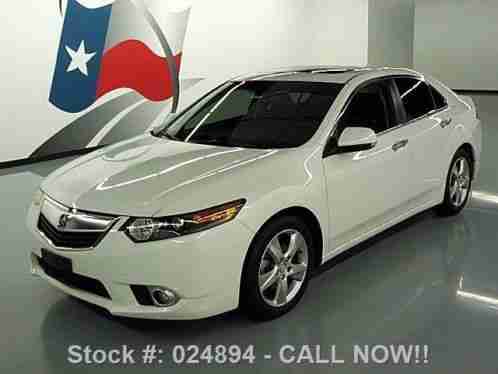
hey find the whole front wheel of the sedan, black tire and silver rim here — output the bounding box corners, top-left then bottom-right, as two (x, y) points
(240, 216), (314, 321)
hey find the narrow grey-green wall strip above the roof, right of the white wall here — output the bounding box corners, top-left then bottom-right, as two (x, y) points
(368, 0), (415, 67)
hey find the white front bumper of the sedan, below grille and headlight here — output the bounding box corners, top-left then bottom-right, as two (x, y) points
(27, 200), (253, 319)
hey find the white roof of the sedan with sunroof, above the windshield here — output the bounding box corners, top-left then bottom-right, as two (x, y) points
(233, 65), (420, 84)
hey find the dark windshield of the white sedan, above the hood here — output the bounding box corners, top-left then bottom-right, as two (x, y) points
(157, 81), (343, 149)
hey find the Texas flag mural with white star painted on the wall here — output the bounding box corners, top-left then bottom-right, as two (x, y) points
(49, 0), (190, 113)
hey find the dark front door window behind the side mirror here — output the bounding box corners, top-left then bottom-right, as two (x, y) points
(339, 82), (393, 134)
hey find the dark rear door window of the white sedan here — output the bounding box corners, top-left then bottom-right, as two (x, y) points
(395, 78), (434, 121)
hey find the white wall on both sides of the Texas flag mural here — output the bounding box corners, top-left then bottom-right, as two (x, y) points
(0, 0), (368, 163)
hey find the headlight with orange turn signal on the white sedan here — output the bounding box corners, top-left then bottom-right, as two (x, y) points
(123, 199), (246, 243)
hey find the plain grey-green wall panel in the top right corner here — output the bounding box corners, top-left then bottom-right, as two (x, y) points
(414, 0), (498, 90)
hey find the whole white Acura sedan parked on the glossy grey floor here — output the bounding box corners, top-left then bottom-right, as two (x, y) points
(28, 67), (481, 319)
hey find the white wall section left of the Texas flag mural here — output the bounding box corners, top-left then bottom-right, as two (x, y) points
(0, 1), (68, 162)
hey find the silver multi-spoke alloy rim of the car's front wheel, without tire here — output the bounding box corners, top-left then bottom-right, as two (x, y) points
(259, 229), (309, 307)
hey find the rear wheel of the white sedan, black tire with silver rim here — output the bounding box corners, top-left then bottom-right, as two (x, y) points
(436, 148), (474, 217)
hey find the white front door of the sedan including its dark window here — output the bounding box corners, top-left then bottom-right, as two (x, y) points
(323, 80), (412, 255)
